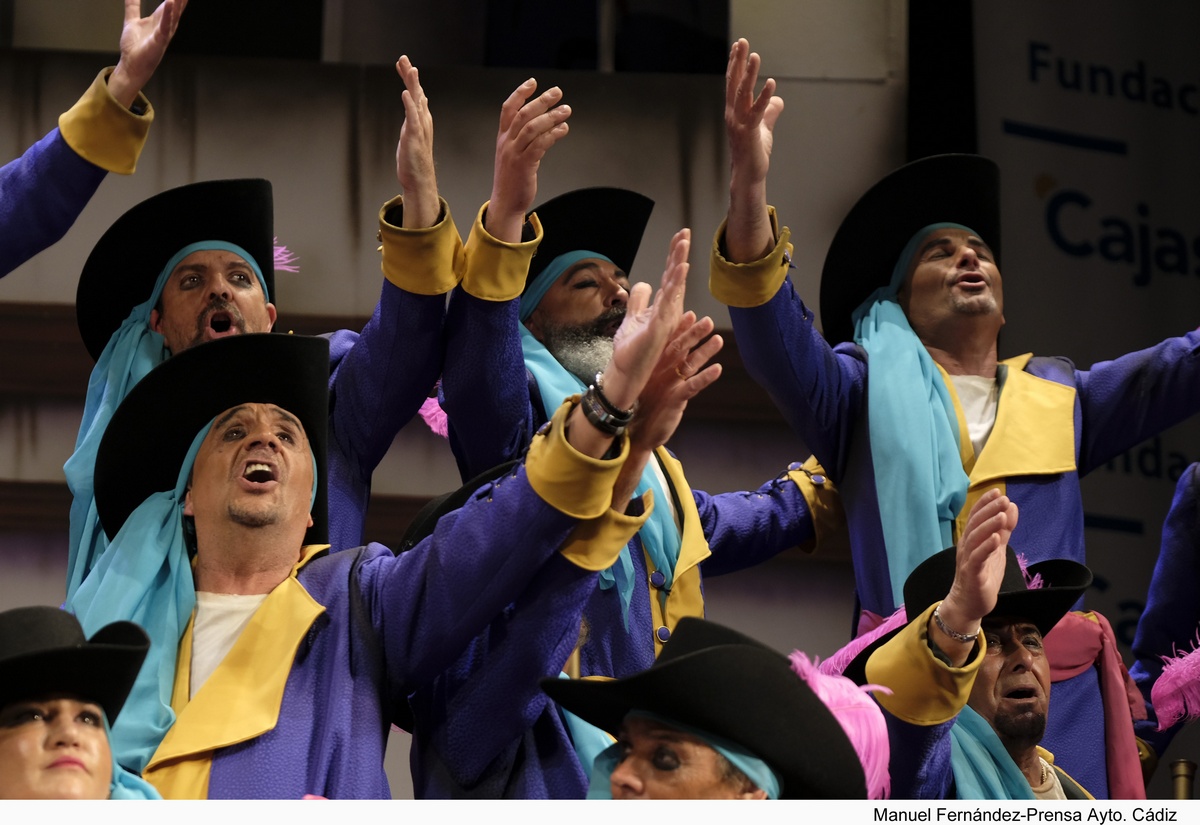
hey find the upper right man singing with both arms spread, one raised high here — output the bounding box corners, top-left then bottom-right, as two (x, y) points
(709, 40), (1200, 797)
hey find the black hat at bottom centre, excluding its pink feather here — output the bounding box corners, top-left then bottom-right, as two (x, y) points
(541, 618), (866, 799)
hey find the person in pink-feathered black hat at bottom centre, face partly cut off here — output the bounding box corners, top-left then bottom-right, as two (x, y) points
(542, 618), (888, 799)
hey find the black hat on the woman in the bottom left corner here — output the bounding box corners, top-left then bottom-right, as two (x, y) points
(0, 607), (150, 724)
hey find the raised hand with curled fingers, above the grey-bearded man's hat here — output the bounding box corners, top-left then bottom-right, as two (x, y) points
(485, 78), (571, 243)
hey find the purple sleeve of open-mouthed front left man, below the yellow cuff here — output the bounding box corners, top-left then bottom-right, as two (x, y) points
(362, 465), (577, 691)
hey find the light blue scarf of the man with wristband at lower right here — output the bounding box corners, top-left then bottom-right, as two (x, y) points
(950, 706), (1033, 800)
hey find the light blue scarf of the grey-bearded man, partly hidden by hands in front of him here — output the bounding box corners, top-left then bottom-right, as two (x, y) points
(521, 324), (683, 631)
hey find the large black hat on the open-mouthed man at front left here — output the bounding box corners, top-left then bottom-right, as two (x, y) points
(95, 332), (329, 544)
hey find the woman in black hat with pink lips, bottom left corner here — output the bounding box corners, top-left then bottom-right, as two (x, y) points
(0, 607), (158, 799)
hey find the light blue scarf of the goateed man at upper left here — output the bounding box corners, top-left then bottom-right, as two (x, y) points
(62, 241), (266, 598)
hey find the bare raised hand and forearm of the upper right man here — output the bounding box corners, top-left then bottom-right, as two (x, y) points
(725, 38), (784, 263)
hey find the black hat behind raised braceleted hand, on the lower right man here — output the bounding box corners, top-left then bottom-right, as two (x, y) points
(842, 547), (1092, 685)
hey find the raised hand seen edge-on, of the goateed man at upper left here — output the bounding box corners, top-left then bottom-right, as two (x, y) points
(396, 55), (442, 229)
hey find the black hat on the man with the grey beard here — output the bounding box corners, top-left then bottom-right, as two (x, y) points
(526, 186), (654, 287)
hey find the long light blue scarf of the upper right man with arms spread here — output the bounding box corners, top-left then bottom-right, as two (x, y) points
(853, 223), (973, 608)
